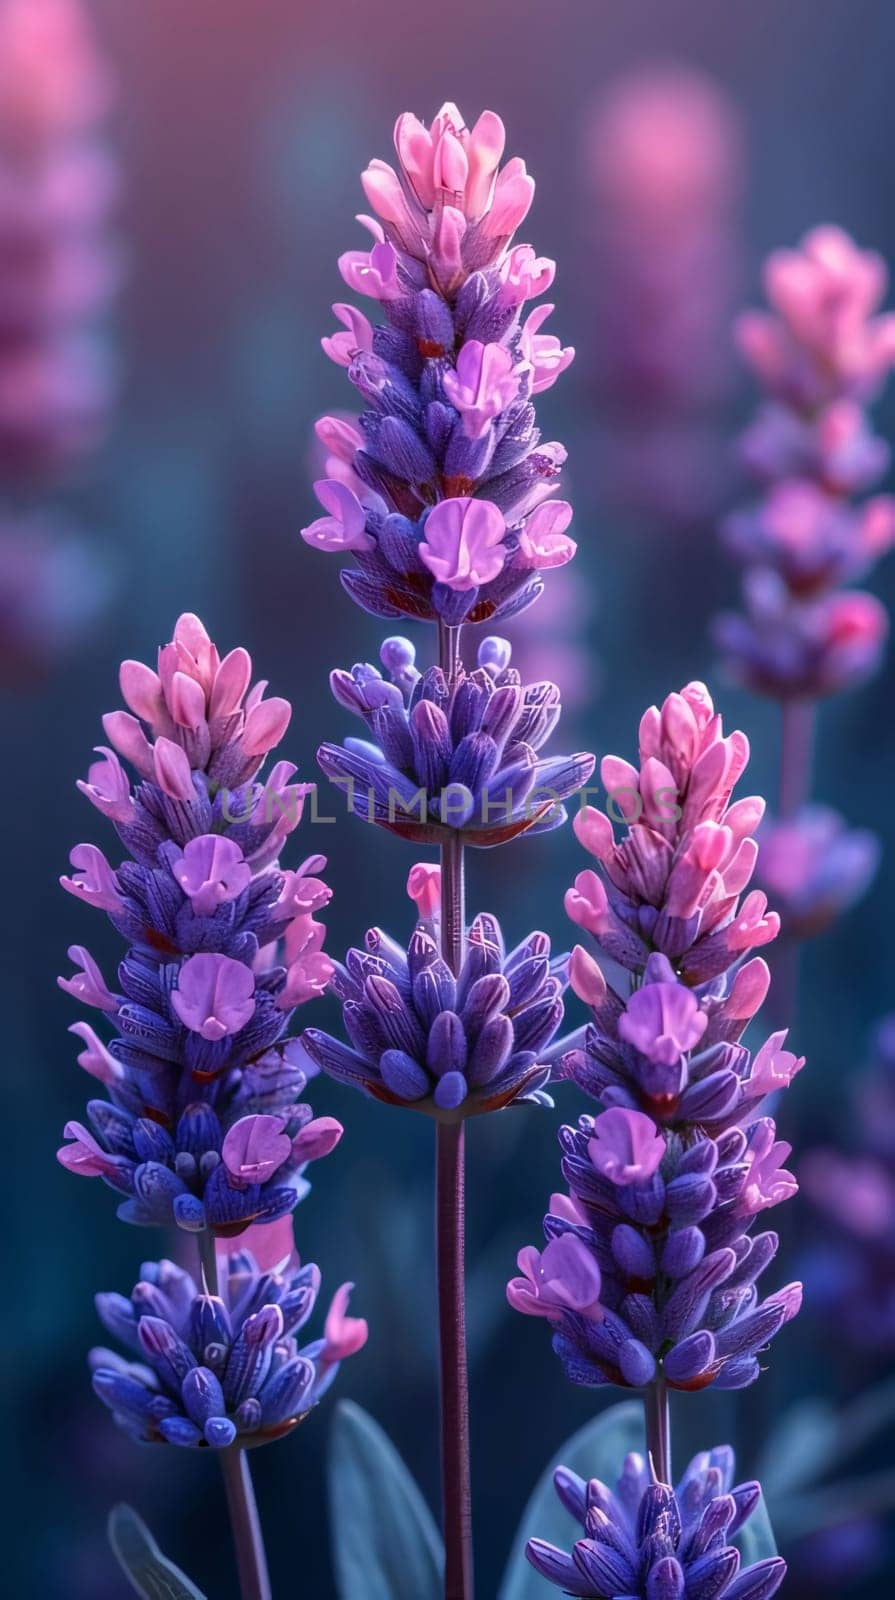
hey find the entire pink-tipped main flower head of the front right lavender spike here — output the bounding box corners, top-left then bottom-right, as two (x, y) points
(508, 685), (802, 1389)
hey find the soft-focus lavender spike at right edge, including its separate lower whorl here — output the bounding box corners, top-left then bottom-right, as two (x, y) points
(714, 227), (895, 960)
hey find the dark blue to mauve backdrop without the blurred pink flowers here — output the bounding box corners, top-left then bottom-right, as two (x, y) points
(7, 0), (895, 1600)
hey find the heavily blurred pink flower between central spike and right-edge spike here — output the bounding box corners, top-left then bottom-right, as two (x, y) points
(584, 66), (743, 411)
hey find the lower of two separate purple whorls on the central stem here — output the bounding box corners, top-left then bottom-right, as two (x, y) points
(303, 915), (565, 1120)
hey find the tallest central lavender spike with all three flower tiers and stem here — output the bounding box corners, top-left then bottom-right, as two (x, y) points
(304, 104), (599, 1600)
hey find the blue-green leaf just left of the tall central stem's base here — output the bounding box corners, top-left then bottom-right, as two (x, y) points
(327, 1400), (445, 1600)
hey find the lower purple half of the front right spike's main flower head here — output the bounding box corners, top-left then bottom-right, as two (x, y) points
(508, 1109), (801, 1390)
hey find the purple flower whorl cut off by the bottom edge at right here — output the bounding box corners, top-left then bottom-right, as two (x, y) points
(525, 1446), (786, 1600)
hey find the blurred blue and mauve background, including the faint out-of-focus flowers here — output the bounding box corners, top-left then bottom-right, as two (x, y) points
(7, 0), (895, 1600)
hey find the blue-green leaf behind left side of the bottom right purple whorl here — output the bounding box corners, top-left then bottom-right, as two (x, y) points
(500, 1400), (644, 1600)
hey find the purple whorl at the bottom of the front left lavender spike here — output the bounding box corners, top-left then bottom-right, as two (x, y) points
(90, 1250), (367, 1450)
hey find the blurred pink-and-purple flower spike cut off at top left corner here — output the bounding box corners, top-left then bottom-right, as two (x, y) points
(0, 0), (120, 477)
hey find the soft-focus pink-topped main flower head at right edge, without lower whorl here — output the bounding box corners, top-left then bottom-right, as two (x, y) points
(716, 227), (895, 699)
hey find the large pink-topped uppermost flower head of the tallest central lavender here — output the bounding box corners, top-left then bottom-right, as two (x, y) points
(303, 104), (575, 626)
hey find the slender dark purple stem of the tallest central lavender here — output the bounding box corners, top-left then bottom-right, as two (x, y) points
(435, 622), (474, 1600)
